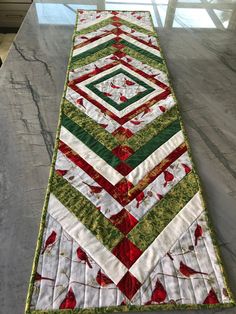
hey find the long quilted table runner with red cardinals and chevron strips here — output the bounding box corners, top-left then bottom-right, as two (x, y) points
(26, 11), (233, 314)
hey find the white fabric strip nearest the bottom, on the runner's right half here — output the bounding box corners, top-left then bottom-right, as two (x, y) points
(129, 192), (204, 283)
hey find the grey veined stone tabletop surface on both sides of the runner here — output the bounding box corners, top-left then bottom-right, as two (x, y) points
(0, 0), (236, 314)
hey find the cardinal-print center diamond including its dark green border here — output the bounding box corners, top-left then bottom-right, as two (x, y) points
(86, 69), (154, 111)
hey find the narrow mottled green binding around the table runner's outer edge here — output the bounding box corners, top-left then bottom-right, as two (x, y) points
(25, 10), (236, 314)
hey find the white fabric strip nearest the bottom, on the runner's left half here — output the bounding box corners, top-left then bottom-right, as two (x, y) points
(48, 194), (127, 284)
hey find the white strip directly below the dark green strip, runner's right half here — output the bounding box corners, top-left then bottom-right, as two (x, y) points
(126, 131), (184, 185)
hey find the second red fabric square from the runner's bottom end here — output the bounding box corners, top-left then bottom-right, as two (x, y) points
(112, 238), (143, 268)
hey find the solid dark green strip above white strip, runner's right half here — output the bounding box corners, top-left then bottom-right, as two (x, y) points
(125, 119), (181, 168)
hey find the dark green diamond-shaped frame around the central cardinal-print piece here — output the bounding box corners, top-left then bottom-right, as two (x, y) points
(86, 69), (154, 111)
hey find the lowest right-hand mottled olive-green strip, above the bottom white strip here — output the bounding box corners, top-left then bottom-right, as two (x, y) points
(128, 172), (199, 251)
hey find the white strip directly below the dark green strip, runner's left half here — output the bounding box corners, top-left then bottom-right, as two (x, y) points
(60, 126), (123, 185)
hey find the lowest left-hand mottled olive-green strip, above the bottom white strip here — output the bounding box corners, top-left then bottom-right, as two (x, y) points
(51, 173), (123, 250)
